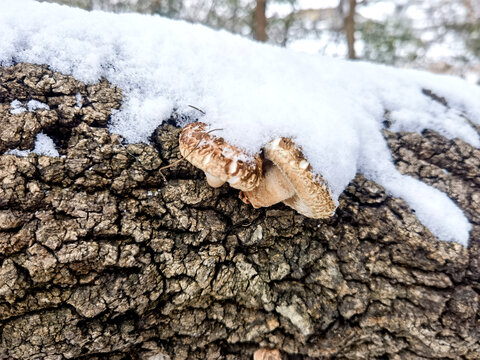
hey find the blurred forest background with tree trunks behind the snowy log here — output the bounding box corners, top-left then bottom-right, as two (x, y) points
(38, 0), (480, 84)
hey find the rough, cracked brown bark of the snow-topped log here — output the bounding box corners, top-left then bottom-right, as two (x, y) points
(0, 64), (480, 360)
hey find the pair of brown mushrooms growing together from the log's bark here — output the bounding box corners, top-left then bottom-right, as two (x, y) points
(179, 122), (335, 219)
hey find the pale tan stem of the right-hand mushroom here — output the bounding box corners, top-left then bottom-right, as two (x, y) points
(240, 162), (295, 208)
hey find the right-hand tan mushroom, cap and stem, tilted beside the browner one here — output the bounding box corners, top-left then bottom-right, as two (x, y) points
(240, 138), (335, 219)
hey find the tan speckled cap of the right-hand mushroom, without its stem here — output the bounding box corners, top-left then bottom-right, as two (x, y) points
(264, 138), (336, 219)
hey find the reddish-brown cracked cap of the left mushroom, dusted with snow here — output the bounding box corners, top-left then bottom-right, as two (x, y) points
(179, 122), (262, 191)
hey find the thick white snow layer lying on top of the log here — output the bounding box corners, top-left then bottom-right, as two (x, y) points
(0, 0), (480, 245)
